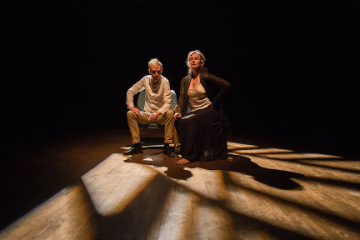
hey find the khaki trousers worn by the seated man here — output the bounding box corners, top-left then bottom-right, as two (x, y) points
(127, 109), (174, 144)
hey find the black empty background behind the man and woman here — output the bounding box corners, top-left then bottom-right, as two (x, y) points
(1, 0), (360, 153)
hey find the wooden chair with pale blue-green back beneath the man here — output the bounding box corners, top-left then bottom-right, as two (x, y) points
(136, 90), (179, 150)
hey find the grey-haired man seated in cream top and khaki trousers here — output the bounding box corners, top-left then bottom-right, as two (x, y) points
(124, 58), (175, 157)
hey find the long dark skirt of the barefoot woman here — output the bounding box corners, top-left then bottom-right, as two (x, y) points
(175, 106), (227, 161)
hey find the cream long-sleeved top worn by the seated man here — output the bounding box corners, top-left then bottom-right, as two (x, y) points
(126, 75), (171, 114)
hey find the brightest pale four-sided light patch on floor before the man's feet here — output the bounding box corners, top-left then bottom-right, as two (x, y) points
(81, 153), (157, 216)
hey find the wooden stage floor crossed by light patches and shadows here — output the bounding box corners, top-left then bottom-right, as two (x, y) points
(0, 131), (360, 240)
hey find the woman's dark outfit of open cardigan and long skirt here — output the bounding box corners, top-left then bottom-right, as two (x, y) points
(175, 72), (231, 161)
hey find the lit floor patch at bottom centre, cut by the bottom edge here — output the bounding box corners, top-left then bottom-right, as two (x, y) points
(147, 174), (232, 239)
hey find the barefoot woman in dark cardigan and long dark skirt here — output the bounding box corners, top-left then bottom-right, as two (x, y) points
(174, 50), (231, 164)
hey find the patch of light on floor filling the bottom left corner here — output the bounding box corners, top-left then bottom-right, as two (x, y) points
(0, 183), (96, 240)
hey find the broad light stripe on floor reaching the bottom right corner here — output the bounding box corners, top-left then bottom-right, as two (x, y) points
(227, 172), (360, 239)
